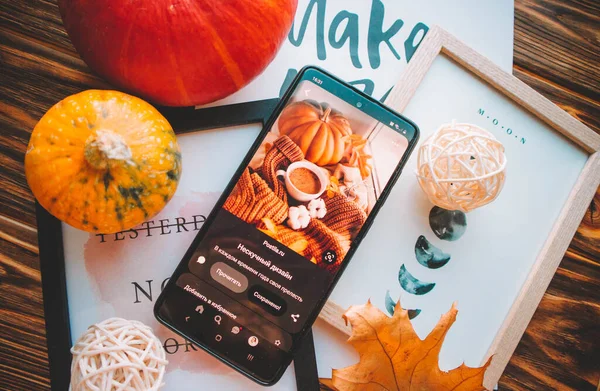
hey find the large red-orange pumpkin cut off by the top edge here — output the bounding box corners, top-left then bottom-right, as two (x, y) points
(58, 0), (298, 106)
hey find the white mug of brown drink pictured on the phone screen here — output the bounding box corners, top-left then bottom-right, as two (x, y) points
(277, 160), (329, 202)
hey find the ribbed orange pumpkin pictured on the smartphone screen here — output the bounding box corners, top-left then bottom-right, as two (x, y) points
(277, 100), (352, 166)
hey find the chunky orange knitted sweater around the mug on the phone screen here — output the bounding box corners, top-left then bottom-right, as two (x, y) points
(224, 136), (367, 272)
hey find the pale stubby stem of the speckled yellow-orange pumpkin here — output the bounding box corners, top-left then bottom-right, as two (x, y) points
(84, 129), (132, 169)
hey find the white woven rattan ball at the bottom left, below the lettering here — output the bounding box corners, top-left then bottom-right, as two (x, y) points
(70, 318), (168, 391)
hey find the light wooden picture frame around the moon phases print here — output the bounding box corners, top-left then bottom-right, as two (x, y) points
(317, 26), (600, 389)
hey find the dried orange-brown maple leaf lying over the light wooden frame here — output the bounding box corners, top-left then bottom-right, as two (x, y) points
(332, 301), (491, 391)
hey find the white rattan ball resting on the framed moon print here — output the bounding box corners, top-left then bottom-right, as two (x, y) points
(416, 122), (506, 212)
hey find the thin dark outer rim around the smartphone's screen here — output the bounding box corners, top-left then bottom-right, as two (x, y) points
(154, 66), (420, 390)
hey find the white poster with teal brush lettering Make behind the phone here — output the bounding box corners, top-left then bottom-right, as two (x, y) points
(207, 0), (514, 107)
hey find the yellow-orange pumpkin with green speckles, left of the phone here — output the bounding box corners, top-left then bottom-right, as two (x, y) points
(25, 90), (181, 233)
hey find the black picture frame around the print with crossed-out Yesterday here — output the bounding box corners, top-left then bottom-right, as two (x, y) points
(36, 98), (319, 390)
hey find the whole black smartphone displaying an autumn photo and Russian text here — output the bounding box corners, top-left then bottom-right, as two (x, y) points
(154, 67), (419, 385)
